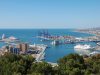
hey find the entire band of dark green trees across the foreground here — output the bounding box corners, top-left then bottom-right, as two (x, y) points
(0, 53), (100, 75)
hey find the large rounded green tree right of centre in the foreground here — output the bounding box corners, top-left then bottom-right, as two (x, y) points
(58, 54), (85, 75)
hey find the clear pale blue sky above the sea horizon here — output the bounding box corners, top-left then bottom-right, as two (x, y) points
(0, 0), (100, 29)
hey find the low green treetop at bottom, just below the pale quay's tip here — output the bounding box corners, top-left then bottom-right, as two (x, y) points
(29, 62), (53, 75)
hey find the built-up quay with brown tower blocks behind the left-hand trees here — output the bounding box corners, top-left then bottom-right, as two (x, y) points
(0, 43), (47, 62)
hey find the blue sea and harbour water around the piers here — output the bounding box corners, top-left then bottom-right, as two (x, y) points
(0, 29), (94, 62)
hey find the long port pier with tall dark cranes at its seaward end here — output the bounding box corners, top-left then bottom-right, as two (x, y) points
(37, 32), (100, 44)
